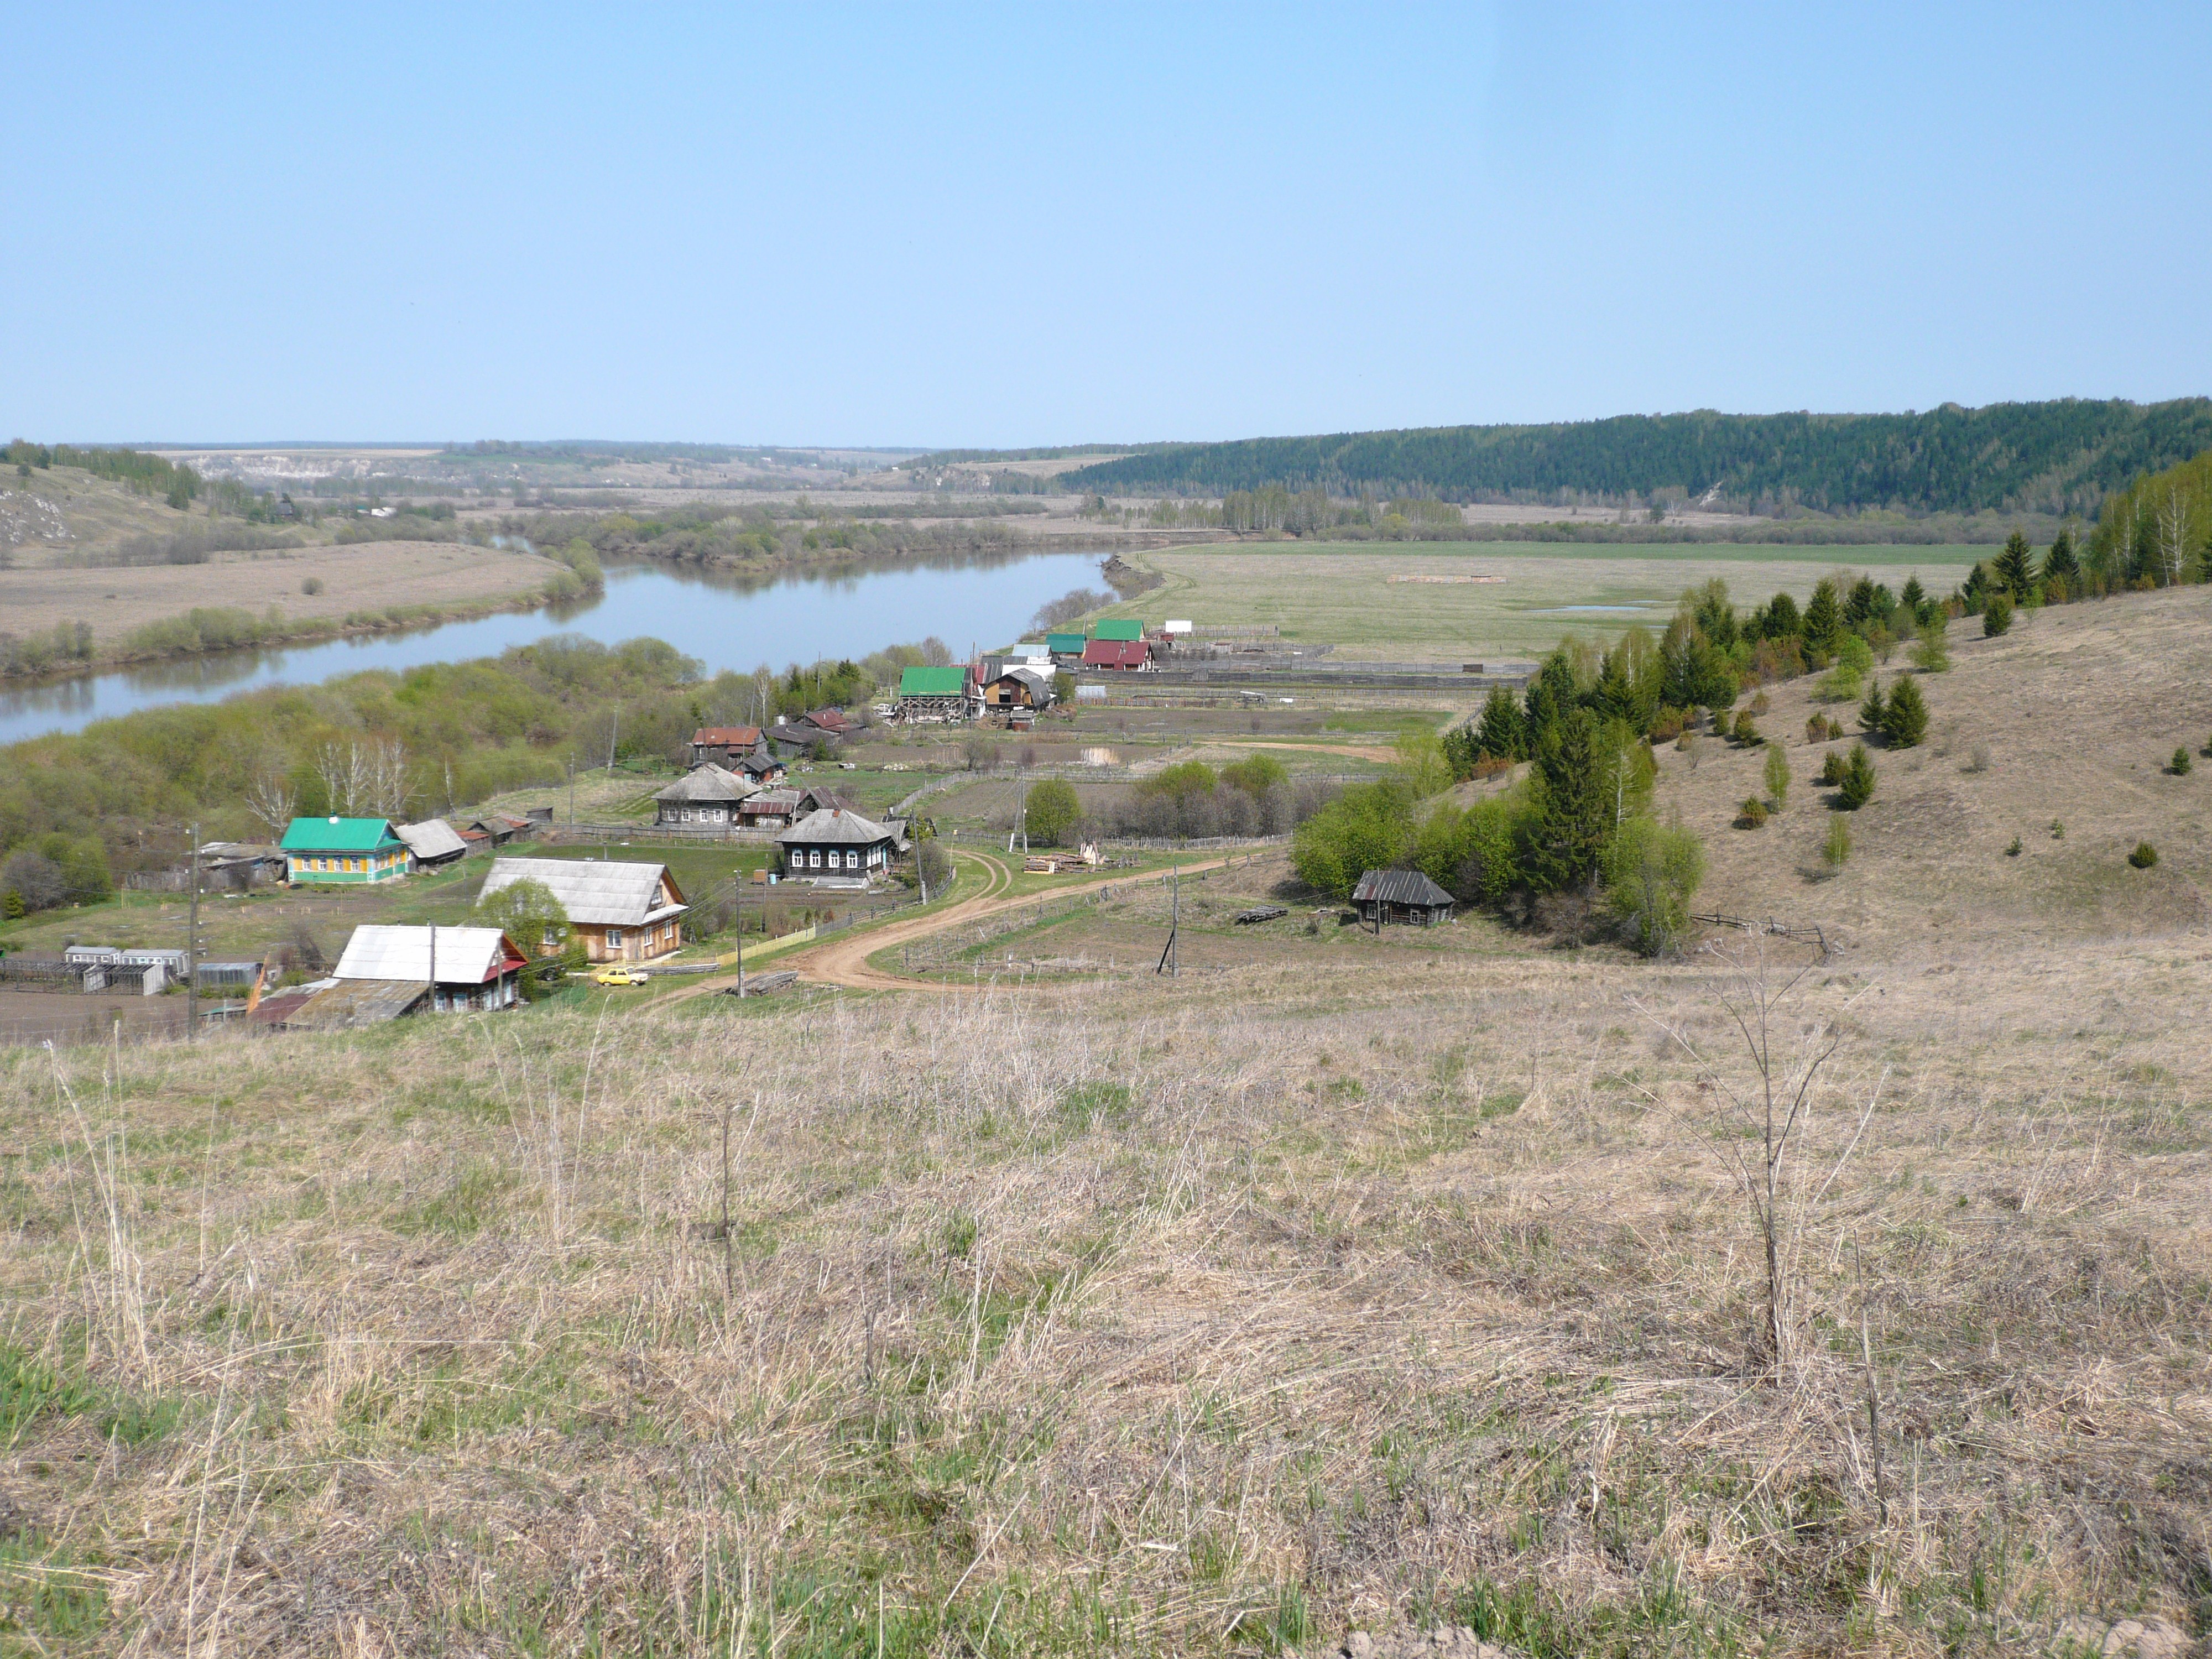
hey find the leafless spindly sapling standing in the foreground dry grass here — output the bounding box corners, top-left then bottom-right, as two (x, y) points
(1635, 929), (1889, 1369)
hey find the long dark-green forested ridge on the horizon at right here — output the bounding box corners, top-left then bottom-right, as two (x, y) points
(1057, 398), (2212, 515)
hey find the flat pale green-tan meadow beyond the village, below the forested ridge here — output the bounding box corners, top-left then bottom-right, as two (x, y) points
(1104, 542), (1991, 661)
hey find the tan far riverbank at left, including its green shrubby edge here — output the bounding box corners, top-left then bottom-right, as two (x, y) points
(0, 542), (591, 681)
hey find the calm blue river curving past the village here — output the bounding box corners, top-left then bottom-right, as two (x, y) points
(0, 553), (1099, 743)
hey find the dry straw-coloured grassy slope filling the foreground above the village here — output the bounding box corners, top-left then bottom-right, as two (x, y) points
(0, 916), (2212, 1655)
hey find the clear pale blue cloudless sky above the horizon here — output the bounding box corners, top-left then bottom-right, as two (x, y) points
(0, 2), (2212, 445)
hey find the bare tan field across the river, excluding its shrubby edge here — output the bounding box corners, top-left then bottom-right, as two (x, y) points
(0, 542), (560, 657)
